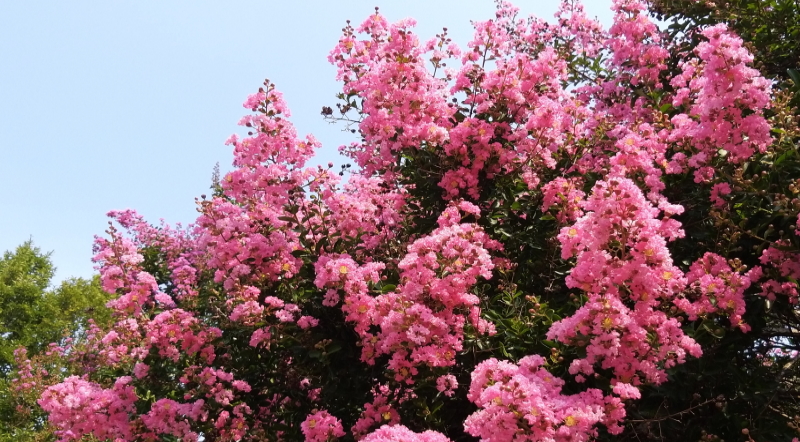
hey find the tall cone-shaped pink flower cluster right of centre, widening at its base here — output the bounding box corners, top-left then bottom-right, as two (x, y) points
(547, 178), (701, 384)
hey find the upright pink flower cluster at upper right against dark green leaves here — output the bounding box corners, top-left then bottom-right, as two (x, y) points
(669, 24), (772, 183)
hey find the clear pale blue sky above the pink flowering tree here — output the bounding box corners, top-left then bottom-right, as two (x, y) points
(0, 0), (611, 281)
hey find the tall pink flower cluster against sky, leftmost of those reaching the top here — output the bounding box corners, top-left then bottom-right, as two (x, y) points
(328, 13), (455, 176)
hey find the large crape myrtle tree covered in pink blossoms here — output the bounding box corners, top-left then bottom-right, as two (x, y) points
(30, 0), (800, 442)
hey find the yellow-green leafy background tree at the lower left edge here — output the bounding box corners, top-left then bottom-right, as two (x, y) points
(0, 241), (110, 440)
